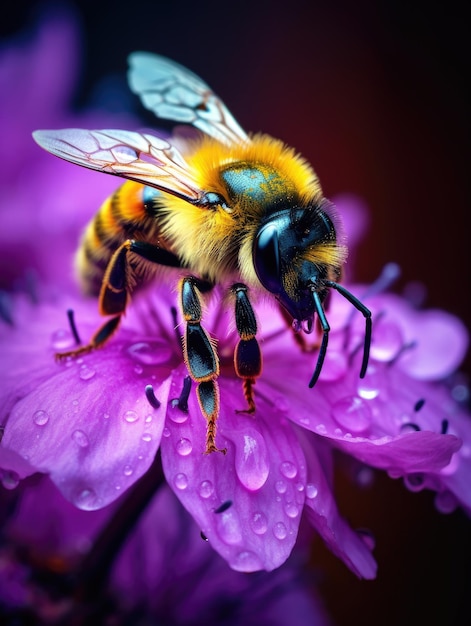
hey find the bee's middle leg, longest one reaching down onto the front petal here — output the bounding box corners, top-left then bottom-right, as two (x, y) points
(180, 276), (226, 454)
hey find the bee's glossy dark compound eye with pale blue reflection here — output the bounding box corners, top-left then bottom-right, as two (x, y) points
(253, 223), (281, 294)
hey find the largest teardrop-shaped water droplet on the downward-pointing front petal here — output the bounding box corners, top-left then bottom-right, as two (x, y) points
(235, 429), (270, 491)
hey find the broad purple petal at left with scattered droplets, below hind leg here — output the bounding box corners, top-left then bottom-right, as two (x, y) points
(0, 342), (170, 510)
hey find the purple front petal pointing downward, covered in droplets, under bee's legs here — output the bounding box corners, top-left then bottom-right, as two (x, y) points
(162, 368), (306, 572)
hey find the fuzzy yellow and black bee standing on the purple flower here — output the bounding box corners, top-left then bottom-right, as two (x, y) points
(33, 52), (371, 454)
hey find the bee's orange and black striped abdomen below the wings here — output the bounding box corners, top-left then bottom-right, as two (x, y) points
(76, 181), (160, 296)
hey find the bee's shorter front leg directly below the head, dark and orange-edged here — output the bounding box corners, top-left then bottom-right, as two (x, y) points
(231, 283), (262, 413)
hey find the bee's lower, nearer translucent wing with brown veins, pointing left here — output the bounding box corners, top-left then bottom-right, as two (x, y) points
(33, 128), (202, 204)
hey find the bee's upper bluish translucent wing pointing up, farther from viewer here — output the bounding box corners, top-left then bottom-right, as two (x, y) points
(128, 52), (249, 145)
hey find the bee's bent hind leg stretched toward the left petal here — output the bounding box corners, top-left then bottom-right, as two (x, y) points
(56, 239), (180, 359)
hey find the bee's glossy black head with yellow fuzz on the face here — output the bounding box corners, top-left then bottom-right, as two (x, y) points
(253, 200), (346, 324)
